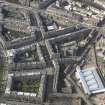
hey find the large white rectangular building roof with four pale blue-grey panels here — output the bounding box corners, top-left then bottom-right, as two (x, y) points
(77, 67), (105, 95)
